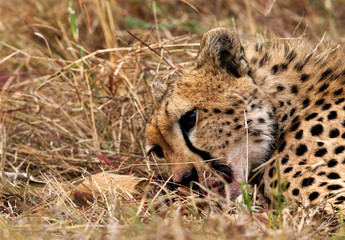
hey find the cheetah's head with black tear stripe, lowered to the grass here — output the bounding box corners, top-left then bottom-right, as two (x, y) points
(145, 28), (275, 199)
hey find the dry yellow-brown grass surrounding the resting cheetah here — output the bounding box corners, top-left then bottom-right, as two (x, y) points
(0, 0), (345, 239)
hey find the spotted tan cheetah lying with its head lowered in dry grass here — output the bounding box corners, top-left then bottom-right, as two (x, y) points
(145, 27), (345, 213)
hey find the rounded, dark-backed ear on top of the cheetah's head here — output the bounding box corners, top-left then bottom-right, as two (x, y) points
(197, 27), (249, 78)
